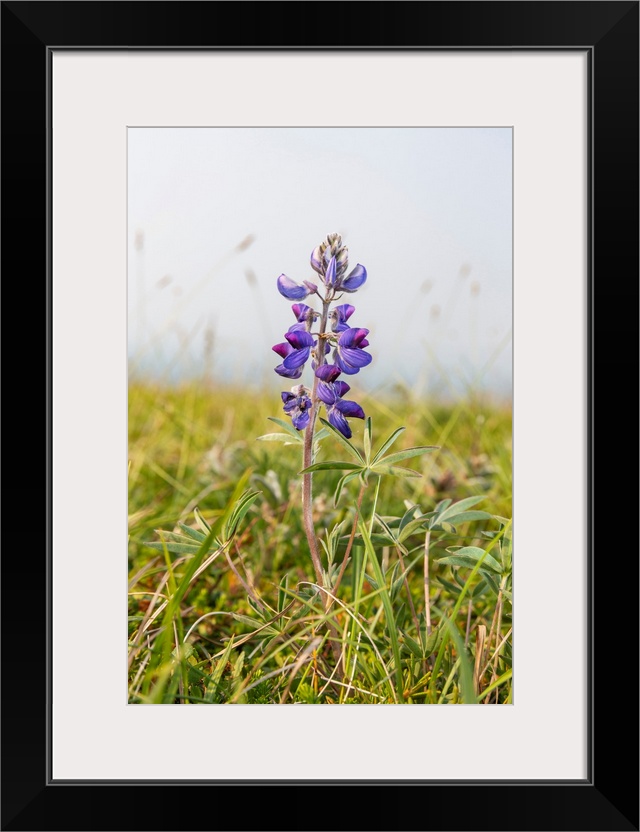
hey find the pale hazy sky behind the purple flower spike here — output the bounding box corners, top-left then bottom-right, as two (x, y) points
(128, 127), (512, 396)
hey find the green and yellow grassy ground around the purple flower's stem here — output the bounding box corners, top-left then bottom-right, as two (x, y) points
(128, 382), (512, 705)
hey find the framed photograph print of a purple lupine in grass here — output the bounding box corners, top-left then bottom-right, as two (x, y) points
(127, 126), (513, 706)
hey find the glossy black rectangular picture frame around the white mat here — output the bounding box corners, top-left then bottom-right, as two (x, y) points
(1, 0), (639, 830)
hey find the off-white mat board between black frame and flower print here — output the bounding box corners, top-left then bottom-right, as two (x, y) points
(53, 52), (587, 780)
